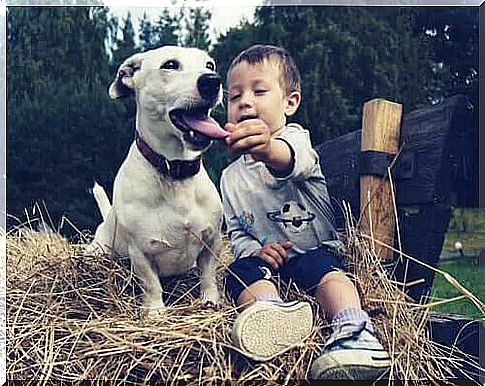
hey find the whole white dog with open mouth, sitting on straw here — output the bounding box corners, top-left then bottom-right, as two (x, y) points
(91, 46), (227, 316)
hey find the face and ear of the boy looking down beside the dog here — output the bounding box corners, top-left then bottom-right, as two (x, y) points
(228, 59), (300, 134)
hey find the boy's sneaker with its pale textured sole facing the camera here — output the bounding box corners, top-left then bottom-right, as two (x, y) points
(232, 301), (313, 361)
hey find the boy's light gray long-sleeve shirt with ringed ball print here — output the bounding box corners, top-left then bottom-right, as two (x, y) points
(221, 124), (340, 258)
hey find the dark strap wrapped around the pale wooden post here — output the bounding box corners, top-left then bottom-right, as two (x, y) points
(359, 150), (415, 179)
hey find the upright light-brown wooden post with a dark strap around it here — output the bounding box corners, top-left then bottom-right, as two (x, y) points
(360, 99), (402, 260)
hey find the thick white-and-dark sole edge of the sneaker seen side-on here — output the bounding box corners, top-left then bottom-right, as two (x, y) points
(311, 349), (391, 380)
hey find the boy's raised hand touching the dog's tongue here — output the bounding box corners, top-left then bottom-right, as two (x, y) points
(224, 119), (273, 162)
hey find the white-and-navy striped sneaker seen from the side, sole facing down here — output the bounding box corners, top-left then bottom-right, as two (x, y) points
(310, 322), (391, 380)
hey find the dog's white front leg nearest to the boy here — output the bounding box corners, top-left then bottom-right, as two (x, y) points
(197, 232), (222, 304)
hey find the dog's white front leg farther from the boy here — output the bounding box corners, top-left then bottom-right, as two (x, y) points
(128, 245), (167, 317)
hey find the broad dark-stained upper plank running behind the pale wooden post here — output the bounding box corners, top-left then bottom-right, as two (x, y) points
(316, 95), (472, 211)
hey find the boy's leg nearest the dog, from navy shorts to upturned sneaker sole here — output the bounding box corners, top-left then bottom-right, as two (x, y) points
(226, 257), (313, 361)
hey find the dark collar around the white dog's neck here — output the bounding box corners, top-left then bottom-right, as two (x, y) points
(135, 130), (201, 180)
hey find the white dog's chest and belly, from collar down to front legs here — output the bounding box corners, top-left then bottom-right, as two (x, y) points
(113, 148), (222, 276)
